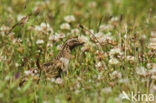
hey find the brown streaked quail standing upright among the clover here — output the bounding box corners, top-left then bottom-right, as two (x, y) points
(20, 37), (84, 85)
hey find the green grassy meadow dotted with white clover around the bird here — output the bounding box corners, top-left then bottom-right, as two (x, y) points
(0, 0), (156, 103)
